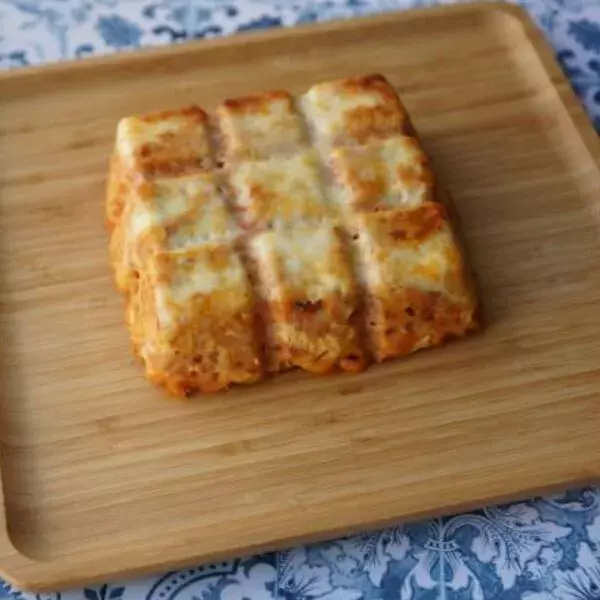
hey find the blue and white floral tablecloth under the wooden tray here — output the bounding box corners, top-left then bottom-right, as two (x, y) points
(0, 0), (600, 600)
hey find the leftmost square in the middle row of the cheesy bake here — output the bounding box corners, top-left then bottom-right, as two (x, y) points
(111, 173), (238, 290)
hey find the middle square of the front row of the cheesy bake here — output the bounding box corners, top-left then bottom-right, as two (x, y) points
(250, 227), (366, 373)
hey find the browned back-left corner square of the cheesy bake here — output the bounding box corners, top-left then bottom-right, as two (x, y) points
(116, 106), (213, 177)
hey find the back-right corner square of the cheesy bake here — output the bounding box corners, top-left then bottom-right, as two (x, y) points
(302, 75), (412, 146)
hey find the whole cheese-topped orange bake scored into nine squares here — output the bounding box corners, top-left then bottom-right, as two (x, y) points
(107, 75), (479, 396)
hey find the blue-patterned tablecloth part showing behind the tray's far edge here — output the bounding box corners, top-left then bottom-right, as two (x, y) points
(0, 0), (600, 128)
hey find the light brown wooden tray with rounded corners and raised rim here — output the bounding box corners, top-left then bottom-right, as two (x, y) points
(0, 4), (600, 588)
